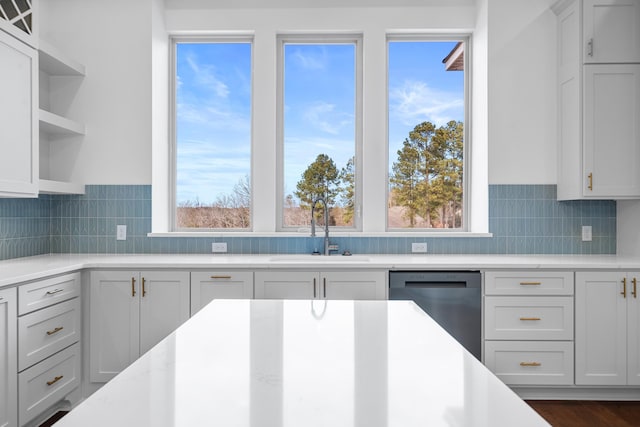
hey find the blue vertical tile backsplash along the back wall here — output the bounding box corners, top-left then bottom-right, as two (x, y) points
(0, 185), (616, 259)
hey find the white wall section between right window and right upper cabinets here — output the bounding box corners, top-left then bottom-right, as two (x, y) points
(489, 0), (557, 184)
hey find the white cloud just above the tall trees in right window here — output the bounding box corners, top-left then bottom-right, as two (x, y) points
(389, 81), (464, 126)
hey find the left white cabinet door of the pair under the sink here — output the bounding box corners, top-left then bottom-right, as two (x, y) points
(255, 271), (319, 299)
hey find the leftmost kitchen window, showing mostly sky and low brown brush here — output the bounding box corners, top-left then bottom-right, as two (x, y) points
(171, 37), (252, 231)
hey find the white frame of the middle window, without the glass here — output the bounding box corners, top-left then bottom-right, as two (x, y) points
(275, 32), (364, 233)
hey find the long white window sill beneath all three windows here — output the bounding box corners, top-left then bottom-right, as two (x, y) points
(147, 231), (493, 238)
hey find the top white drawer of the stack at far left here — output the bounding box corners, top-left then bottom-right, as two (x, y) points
(18, 273), (80, 316)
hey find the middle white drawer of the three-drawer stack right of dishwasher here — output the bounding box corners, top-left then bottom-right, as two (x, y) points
(484, 297), (573, 340)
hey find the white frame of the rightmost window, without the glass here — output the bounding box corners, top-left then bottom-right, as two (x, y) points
(384, 33), (473, 234)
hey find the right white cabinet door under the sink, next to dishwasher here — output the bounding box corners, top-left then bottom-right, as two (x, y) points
(320, 271), (387, 300)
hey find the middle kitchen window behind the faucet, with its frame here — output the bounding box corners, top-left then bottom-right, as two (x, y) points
(277, 35), (362, 231)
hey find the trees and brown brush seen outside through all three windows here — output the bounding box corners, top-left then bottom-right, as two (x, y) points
(178, 121), (464, 228)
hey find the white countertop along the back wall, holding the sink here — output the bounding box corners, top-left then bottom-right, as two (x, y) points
(0, 254), (640, 287)
